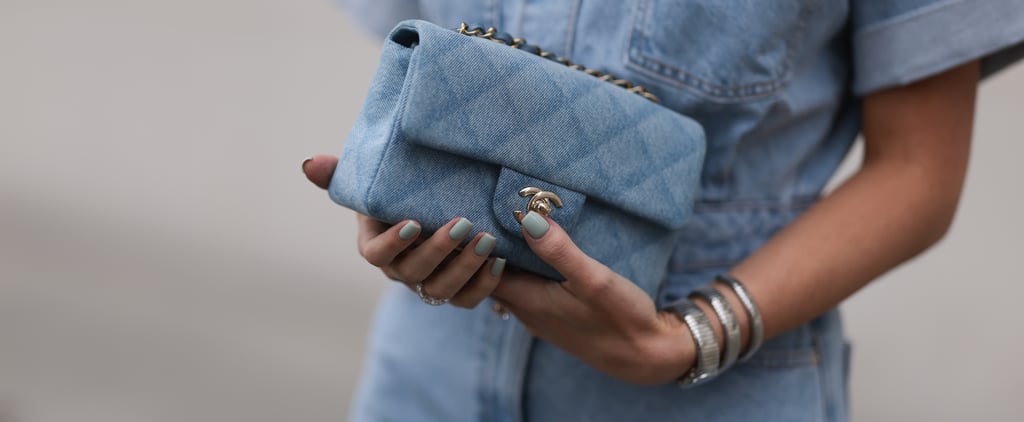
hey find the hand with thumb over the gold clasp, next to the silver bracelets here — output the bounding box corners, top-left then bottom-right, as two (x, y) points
(492, 212), (695, 384)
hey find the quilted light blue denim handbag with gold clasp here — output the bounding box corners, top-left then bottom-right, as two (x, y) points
(329, 20), (705, 295)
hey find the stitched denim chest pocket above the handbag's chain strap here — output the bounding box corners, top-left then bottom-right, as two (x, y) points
(627, 0), (816, 101)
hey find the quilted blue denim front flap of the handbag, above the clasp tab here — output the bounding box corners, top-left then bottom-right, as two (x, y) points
(386, 20), (705, 229)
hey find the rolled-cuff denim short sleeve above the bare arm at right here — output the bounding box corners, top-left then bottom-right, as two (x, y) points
(850, 0), (1024, 95)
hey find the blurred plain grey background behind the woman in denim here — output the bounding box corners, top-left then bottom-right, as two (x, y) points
(0, 0), (1024, 422)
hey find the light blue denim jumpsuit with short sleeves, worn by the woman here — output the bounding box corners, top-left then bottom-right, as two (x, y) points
(337, 0), (1024, 422)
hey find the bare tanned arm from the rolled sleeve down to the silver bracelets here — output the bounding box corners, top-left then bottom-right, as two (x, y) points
(684, 62), (979, 368)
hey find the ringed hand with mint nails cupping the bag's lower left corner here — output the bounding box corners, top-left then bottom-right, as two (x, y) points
(302, 156), (505, 308)
